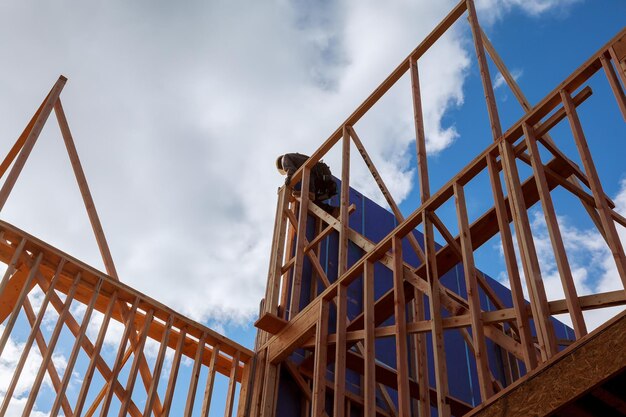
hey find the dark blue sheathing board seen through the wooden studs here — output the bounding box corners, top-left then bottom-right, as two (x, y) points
(276, 183), (573, 417)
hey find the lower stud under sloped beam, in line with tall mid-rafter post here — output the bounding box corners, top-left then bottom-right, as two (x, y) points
(422, 210), (450, 417)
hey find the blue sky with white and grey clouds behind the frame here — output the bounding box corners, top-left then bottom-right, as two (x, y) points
(0, 0), (626, 346)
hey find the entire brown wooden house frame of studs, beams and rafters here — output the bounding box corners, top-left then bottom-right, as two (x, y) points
(0, 0), (626, 417)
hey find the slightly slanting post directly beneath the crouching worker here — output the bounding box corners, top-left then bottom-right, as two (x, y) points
(289, 164), (311, 319)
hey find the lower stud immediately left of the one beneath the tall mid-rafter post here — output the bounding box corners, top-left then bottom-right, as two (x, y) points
(392, 236), (411, 416)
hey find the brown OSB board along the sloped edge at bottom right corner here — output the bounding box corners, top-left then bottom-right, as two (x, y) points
(466, 312), (626, 417)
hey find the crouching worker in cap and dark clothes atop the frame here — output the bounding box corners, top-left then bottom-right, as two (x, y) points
(276, 153), (339, 217)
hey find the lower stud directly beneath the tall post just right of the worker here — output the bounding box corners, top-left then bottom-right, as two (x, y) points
(333, 284), (350, 417)
